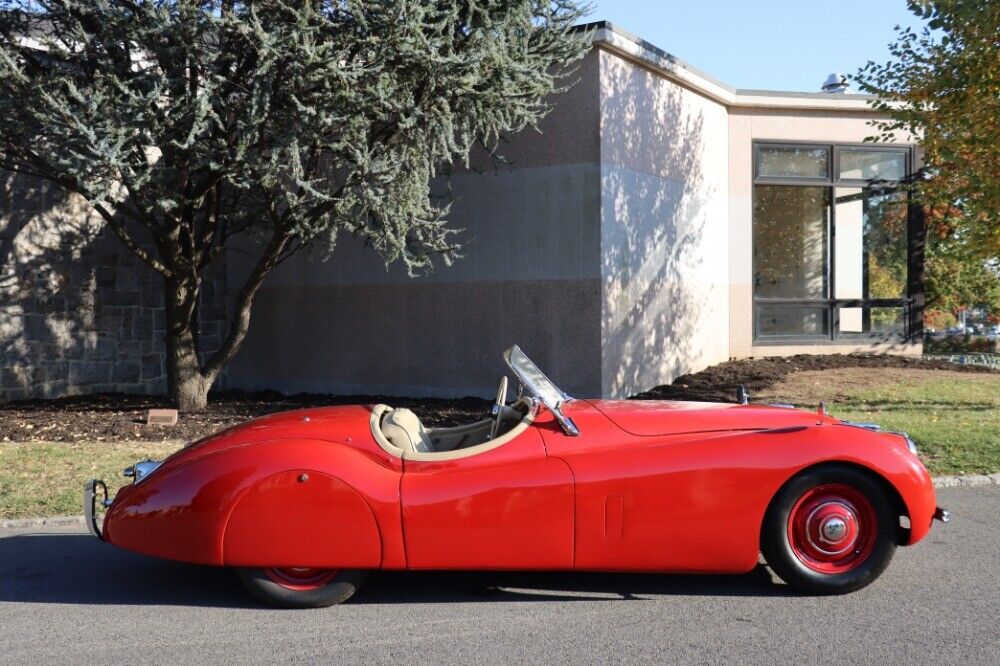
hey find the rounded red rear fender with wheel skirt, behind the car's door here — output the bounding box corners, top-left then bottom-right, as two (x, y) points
(105, 439), (405, 568)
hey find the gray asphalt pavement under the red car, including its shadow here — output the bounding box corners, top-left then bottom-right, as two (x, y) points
(0, 486), (1000, 664)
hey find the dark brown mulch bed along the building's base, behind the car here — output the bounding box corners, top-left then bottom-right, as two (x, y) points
(0, 355), (993, 442)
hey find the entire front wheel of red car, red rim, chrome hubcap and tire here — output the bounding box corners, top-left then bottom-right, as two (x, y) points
(761, 465), (899, 594)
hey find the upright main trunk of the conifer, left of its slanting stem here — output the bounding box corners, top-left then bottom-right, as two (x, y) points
(164, 278), (212, 412)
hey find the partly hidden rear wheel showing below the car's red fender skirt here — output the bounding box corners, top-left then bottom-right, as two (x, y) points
(238, 567), (368, 608)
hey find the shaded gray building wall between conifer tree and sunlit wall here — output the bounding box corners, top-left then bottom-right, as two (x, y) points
(227, 53), (601, 396)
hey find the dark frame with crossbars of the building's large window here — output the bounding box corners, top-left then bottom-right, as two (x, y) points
(750, 140), (923, 346)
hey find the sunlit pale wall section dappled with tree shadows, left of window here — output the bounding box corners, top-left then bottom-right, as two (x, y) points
(600, 50), (729, 397)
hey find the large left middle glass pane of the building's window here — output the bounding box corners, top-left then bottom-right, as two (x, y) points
(753, 185), (830, 298)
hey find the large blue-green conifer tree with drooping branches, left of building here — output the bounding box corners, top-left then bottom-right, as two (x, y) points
(0, 0), (588, 404)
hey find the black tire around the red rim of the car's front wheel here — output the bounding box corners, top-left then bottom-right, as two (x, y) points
(761, 464), (899, 594)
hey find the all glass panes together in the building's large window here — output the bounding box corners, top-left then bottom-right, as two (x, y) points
(752, 144), (913, 344)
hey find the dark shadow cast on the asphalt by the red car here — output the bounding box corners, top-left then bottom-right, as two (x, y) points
(0, 534), (789, 608)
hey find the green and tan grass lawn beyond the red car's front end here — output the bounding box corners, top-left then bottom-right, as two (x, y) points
(754, 368), (1000, 474)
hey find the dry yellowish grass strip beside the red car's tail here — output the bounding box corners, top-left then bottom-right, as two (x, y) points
(0, 442), (181, 518)
